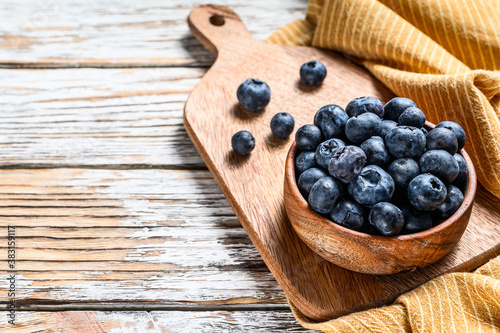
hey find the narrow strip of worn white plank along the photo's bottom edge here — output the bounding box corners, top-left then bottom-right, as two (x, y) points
(0, 311), (317, 333)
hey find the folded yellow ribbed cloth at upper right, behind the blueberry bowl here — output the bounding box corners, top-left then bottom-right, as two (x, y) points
(268, 0), (500, 197)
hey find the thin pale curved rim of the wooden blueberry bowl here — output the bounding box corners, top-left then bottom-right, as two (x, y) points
(285, 121), (477, 243)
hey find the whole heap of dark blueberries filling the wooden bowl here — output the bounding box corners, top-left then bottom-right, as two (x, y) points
(295, 97), (469, 236)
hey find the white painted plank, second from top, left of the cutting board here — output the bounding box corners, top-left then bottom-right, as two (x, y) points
(0, 68), (207, 169)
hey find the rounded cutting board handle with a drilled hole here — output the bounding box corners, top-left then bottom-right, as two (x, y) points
(188, 5), (256, 55)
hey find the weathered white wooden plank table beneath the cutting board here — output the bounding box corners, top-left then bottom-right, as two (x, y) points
(0, 0), (316, 332)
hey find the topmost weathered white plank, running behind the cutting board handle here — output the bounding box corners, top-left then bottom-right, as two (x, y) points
(0, 0), (307, 68)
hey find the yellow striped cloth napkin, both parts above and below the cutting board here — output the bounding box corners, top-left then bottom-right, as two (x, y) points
(268, 0), (500, 332)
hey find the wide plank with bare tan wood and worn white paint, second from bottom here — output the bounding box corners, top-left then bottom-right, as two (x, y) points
(0, 169), (287, 309)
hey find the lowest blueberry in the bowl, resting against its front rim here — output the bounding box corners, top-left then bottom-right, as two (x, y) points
(368, 202), (405, 236)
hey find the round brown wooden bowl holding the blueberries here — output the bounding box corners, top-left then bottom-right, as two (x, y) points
(284, 123), (477, 274)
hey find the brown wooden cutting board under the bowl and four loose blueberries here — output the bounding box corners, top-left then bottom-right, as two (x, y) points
(184, 5), (500, 320)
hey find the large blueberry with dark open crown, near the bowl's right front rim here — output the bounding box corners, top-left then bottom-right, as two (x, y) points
(408, 174), (448, 211)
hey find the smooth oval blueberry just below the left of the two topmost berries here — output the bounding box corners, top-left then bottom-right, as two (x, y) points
(345, 112), (382, 144)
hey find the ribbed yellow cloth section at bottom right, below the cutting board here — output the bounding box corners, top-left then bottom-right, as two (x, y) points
(290, 257), (500, 333)
